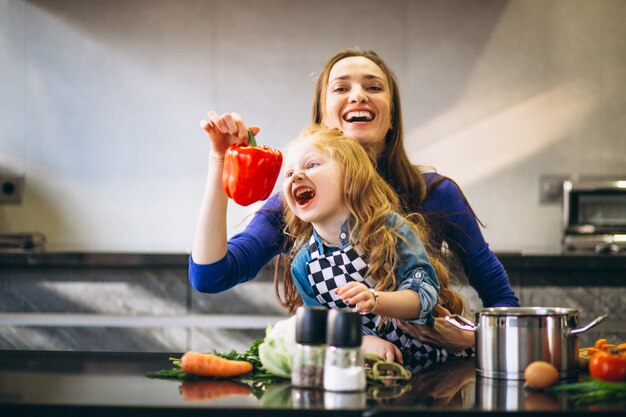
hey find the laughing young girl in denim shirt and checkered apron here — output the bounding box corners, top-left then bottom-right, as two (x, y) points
(282, 125), (469, 370)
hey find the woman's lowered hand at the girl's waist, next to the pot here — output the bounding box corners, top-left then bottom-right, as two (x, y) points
(398, 305), (476, 352)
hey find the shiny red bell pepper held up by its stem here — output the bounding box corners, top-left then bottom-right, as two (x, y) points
(222, 130), (283, 206)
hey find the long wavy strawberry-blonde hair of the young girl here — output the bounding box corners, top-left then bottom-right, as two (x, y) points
(274, 124), (464, 314)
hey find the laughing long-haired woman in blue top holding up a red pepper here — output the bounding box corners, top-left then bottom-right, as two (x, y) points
(189, 49), (519, 359)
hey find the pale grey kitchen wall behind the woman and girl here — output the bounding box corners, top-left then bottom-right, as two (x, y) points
(0, 0), (626, 252)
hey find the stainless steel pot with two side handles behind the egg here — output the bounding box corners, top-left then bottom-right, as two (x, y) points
(446, 307), (607, 379)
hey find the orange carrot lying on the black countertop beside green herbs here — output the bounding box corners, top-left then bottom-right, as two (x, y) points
(180, 352), (252, 378)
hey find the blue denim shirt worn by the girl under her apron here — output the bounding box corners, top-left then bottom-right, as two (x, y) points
(291, 213), (439, 333)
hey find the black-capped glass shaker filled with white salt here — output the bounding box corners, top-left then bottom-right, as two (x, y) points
(324, 310), (366, 392)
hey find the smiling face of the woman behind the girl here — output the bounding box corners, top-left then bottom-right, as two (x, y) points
(322, 56), (391, 154)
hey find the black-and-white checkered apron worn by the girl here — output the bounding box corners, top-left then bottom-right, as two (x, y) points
(306, 236), (473, 372)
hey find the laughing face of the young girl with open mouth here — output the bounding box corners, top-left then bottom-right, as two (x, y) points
(283, 138), (348, 227)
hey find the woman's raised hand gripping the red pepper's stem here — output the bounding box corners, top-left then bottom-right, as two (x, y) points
(200, 111), (261, 159)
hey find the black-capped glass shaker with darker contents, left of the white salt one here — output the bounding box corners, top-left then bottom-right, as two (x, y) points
(291, 307), (328, 388)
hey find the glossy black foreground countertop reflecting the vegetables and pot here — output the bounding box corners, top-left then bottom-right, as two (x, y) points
(0, 351), (626, 417)
